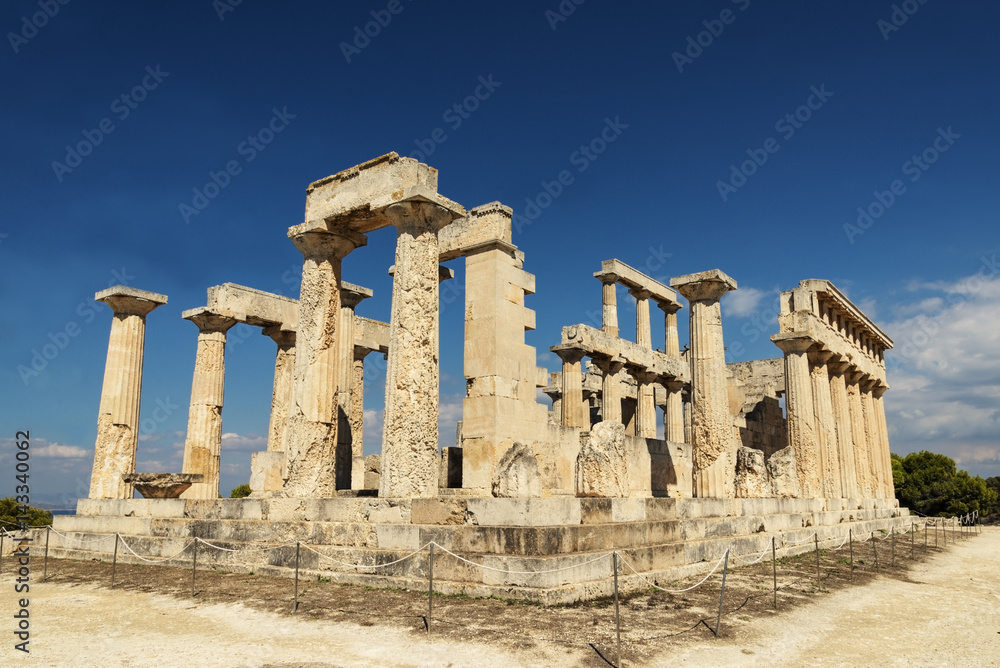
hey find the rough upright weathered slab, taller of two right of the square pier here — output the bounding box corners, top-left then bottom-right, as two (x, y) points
(576, 421), (629, 498)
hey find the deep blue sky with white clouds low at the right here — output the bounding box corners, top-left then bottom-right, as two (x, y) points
(0, 0), (1000, 500)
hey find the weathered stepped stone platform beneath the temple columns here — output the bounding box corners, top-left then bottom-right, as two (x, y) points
(39, 496), (913, 605)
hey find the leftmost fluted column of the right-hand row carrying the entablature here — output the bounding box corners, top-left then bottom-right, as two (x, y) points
(771, 333), (823, 498)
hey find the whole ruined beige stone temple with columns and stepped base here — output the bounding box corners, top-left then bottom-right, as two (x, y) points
(52, 153), (910, 603)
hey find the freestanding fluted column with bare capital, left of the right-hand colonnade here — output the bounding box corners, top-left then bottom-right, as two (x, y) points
(670, 269), (737, 498)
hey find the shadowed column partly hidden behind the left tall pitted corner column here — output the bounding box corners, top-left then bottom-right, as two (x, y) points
(334, 282), (372, 489)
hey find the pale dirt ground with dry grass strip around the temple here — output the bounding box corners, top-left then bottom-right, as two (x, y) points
(0, 527), (1000, 668)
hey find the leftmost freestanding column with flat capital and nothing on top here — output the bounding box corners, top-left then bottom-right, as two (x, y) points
(90, 285), (167, 499)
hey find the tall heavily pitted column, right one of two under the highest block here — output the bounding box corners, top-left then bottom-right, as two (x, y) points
(379, 202), (453, 498)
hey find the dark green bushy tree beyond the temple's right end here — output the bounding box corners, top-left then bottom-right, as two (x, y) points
(892, 450), (997, 517)
